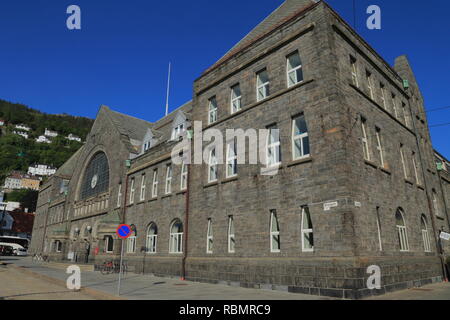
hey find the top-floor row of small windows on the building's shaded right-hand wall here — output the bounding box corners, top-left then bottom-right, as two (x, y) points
(350, 56), (412, 128)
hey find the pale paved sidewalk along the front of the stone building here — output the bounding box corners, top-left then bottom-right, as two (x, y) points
(3, 257), (331, 300)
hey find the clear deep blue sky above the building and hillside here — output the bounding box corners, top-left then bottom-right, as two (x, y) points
(0, 0), (450, 157)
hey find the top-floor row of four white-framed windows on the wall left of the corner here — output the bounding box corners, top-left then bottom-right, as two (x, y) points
(208, 51), (303, 124)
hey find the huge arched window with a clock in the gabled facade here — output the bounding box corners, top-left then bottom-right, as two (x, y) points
(81, 152), (109, 200)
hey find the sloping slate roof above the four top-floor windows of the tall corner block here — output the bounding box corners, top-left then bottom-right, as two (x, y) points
(206, 0), (319, 72)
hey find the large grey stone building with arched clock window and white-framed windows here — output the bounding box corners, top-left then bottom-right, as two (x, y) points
(32, 0), (449, 298)
